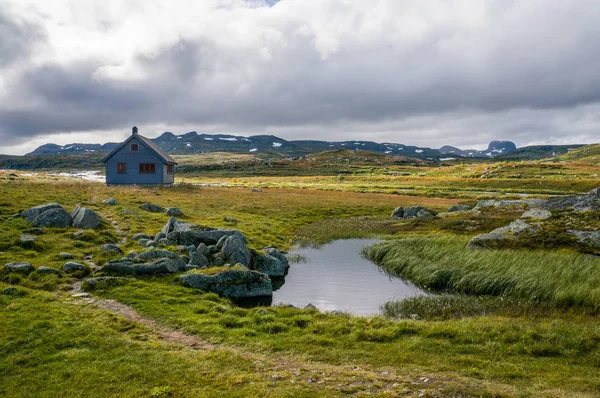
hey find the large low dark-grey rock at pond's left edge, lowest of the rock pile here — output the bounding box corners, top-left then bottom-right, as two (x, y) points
(179, 270), (273, 300)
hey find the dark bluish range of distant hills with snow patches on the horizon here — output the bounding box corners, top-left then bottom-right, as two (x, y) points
(26, 131), (516, 160)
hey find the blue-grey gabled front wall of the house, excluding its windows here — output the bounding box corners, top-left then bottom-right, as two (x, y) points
(106, 138), (167, 185)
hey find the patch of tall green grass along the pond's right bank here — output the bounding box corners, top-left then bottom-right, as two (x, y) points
(364, 237), (600, 312)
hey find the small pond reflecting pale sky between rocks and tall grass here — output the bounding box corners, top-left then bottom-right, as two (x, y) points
(273, 239), (427, 315)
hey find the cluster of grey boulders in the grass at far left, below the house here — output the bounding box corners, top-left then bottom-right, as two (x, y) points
(19, 203), (102, 229)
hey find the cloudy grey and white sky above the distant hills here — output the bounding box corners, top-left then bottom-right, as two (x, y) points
(0, 0), (600, 154)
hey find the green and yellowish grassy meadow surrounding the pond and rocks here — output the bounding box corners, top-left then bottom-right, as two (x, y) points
(0, 159), (600, 397)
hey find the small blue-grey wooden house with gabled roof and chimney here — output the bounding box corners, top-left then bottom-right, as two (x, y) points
(102, 126), (177, 185)
